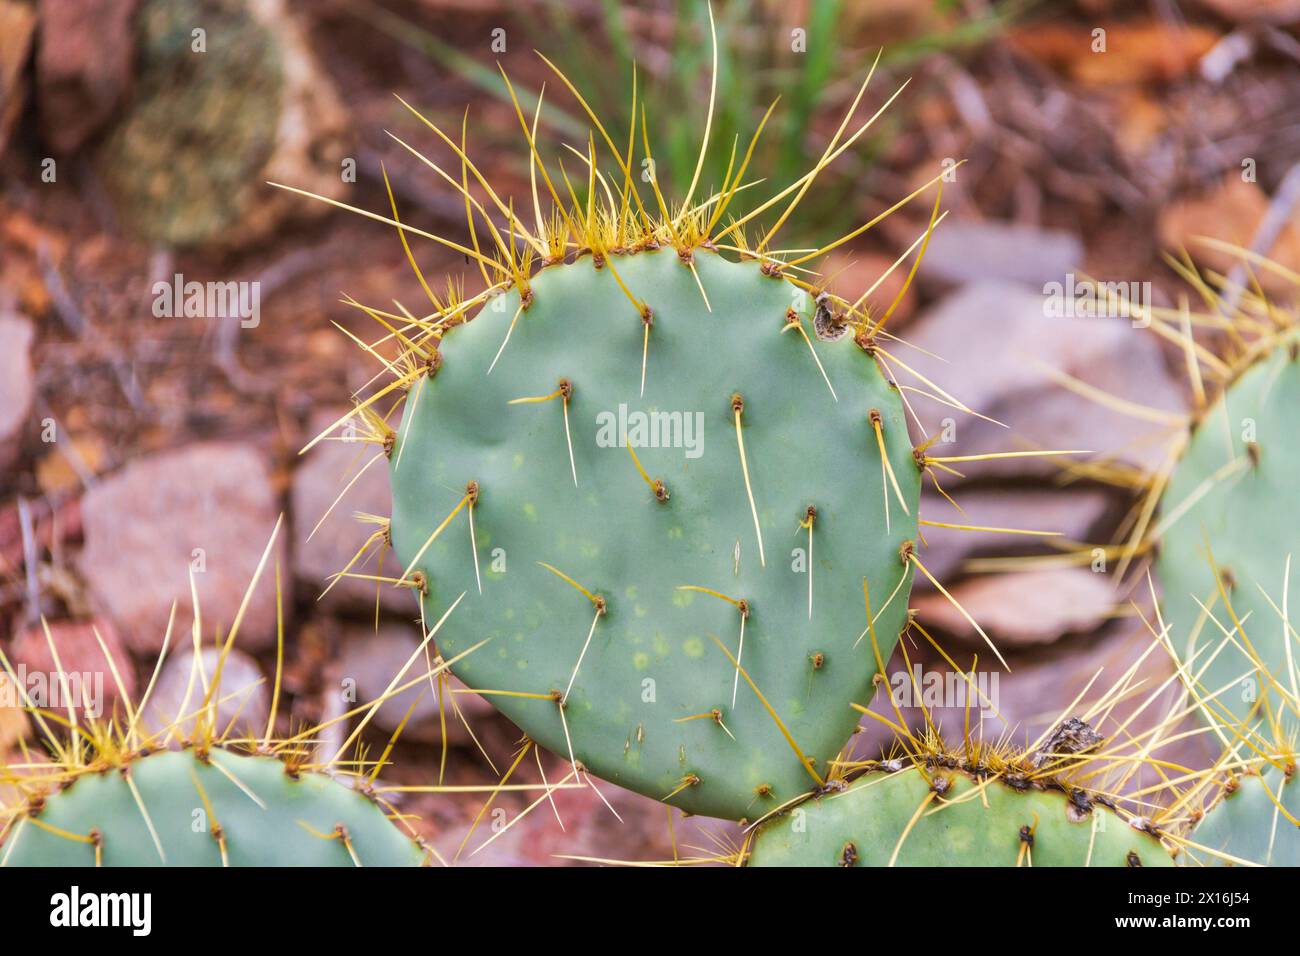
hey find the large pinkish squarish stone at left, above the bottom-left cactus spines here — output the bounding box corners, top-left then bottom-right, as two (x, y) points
(79, 442), (286, 653)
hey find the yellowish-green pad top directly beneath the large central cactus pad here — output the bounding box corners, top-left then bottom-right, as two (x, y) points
(749, 766), (1173, 866)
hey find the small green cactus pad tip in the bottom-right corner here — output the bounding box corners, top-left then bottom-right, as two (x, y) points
(1191, 765), (1300, 866)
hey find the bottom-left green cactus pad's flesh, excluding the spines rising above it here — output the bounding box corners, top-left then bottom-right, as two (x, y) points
(0, 749), (425, 866)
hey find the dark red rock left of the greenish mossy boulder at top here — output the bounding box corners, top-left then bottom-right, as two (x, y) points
(36, 0), (135, 155)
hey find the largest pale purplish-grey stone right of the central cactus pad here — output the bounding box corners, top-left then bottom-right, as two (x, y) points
(887, 282), (1187, 484)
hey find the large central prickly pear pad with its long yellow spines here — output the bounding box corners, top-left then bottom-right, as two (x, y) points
(285, 33), (1045, 819)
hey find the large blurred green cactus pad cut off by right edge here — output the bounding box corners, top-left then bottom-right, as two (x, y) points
(1157, 342), (1300, 726)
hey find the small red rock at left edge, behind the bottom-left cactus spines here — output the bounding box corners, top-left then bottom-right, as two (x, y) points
(9, 619), (135, 721)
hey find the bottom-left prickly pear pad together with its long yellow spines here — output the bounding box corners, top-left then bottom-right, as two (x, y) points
(0, 523), (431, 866)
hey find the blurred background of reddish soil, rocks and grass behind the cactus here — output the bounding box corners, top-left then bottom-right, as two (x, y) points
(0, 0), (1300, 865)
